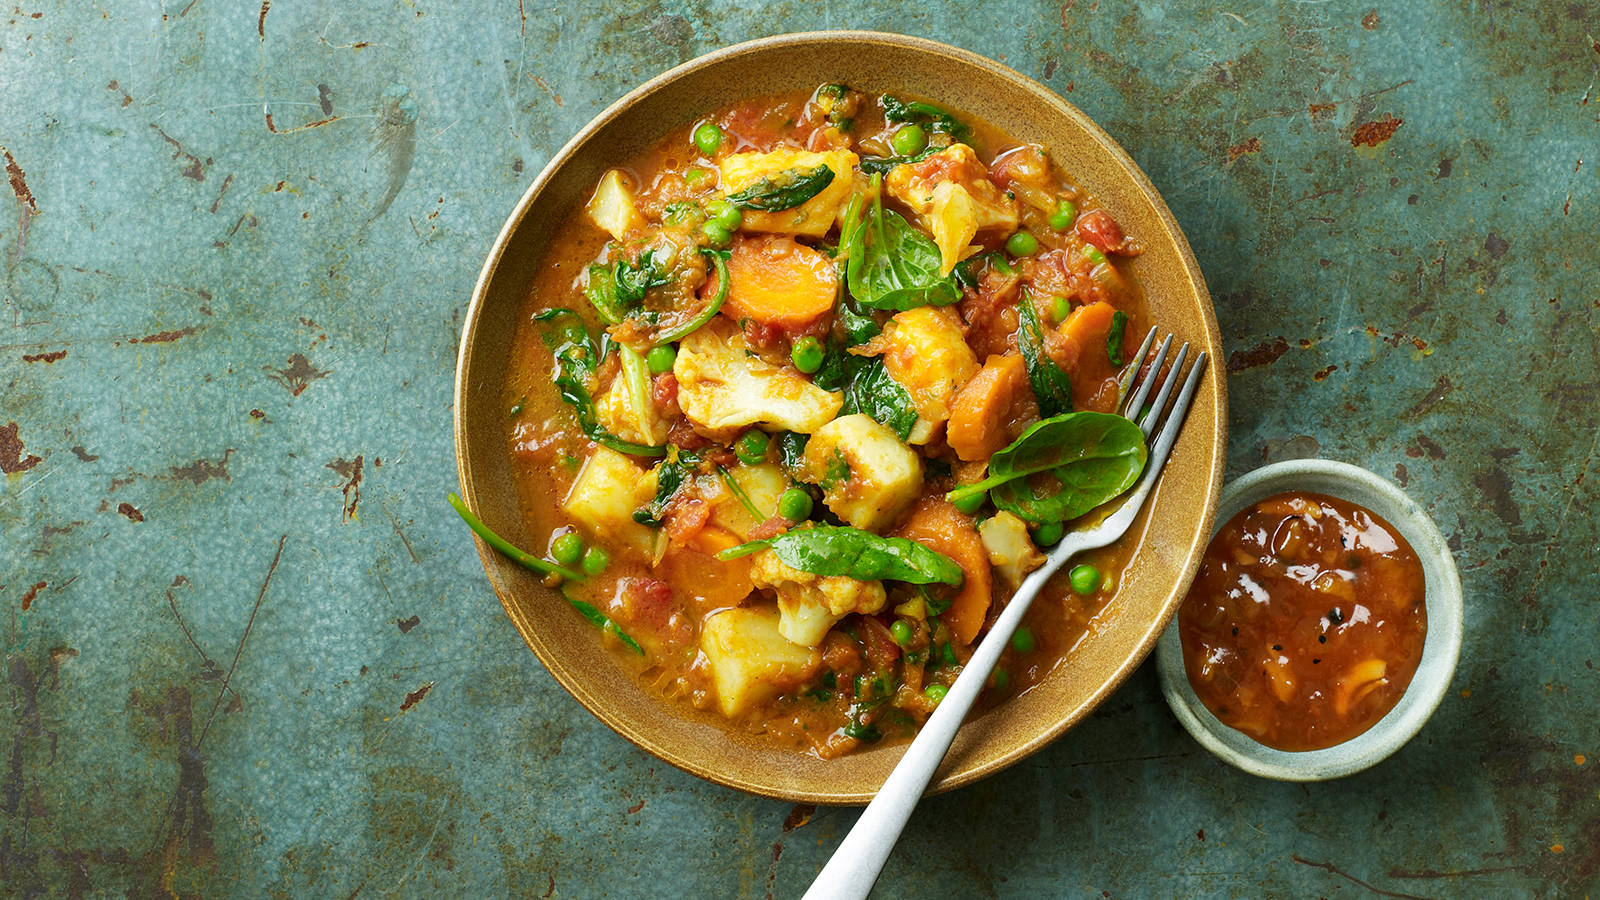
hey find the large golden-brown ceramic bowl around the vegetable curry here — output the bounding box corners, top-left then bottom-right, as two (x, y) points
(454, 32), (1227, 804)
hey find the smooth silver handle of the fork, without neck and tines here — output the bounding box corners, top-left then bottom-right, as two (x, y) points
(805, 538), (1082, 900)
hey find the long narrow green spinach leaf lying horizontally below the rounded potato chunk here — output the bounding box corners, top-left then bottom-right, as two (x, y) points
(717, 525), (963, 588)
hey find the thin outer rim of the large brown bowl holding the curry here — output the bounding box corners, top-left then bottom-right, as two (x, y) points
(451, 29), (1227, 806)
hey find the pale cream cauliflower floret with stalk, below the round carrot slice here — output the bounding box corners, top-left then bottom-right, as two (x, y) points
(672, 317), (845, 440)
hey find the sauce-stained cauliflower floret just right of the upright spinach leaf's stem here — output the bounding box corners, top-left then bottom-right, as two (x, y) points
(885, 144), (1018, 275)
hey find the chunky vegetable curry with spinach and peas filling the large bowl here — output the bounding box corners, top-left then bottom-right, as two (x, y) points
(492, 85), (1149, 757)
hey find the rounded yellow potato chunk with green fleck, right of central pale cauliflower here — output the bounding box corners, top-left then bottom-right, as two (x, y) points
(800, 413), (922, 532)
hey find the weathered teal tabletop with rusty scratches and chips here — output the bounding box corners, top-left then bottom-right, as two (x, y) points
(0, 0), (1600, 897)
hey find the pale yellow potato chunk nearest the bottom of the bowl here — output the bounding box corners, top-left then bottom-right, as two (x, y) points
(701, 605), (822, 719)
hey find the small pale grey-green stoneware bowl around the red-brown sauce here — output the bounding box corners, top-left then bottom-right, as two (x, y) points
(1157, 460), (1464, 781)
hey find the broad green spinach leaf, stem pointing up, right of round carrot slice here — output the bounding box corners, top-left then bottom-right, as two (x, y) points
(840, 176), (962, 309)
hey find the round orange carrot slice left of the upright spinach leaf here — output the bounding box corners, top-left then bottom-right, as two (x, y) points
(723, 235), (838, 328)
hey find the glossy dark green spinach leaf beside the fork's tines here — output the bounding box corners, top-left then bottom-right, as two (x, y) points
(946, 412), (1149, 522)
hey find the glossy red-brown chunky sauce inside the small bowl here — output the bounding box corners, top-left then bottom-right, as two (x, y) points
(1178, 493), (1427, 751)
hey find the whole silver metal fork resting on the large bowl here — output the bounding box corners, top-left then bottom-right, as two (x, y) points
(805, 328), (1206, 900)
